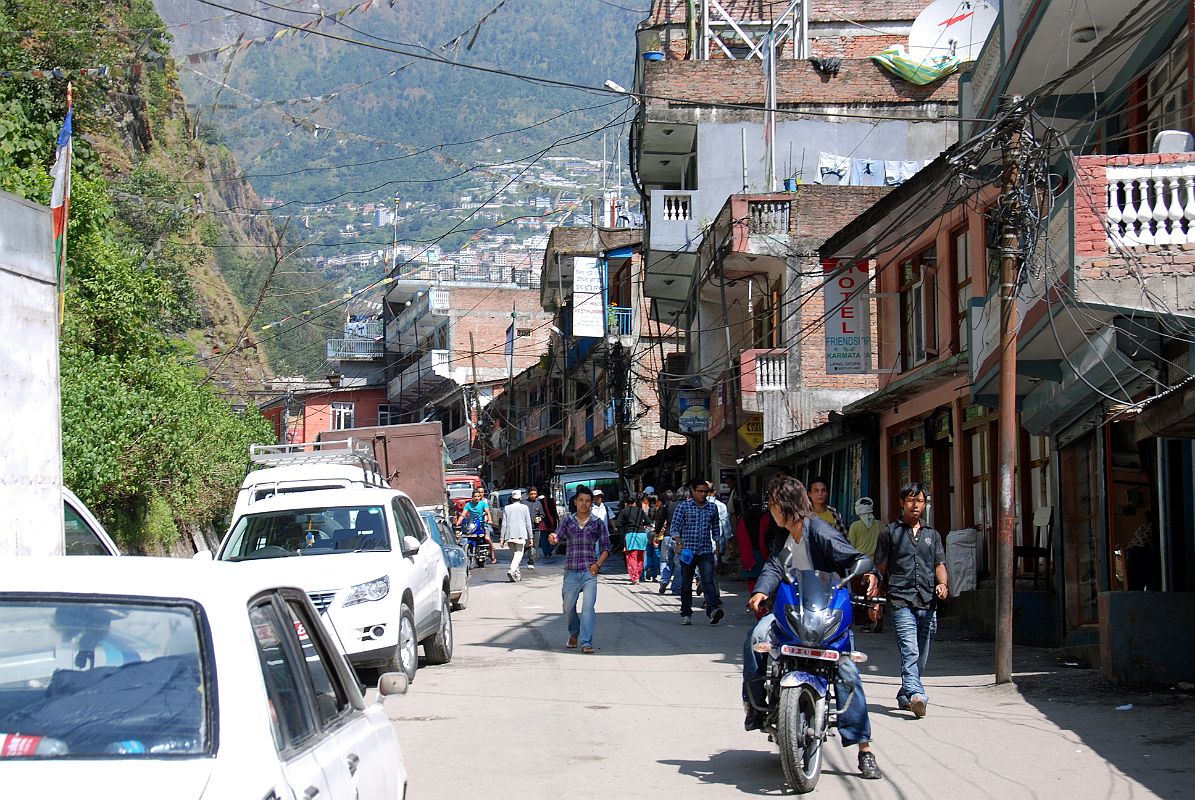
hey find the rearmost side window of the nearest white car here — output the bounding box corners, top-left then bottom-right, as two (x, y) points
(249, 600), (315, 752)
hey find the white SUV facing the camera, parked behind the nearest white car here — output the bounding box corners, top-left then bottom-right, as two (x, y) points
(216, 487), (453, 679)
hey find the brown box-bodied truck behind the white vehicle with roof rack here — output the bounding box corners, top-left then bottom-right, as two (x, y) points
(319, 422), (448, 508)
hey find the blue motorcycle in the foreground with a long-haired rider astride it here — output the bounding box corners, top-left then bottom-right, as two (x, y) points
(749, 558), (883, 794)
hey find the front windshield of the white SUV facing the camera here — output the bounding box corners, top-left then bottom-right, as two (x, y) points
(220, 506), (390, 561)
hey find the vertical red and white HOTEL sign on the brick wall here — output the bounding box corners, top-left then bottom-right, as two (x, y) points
(822, 259), (871, 375)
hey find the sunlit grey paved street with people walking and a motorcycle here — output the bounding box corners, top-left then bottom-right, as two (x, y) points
(396, 552), (1195, 800)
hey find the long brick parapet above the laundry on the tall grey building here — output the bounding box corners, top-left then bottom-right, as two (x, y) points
(644, 59), (958, 109)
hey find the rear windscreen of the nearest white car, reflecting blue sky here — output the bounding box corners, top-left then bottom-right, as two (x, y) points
(0, 594), (215, 761)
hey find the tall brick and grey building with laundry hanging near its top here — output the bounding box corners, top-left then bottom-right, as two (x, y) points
(631, 0), (958, 507)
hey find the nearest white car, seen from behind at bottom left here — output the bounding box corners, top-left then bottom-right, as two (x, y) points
(0, 556), (406, 800)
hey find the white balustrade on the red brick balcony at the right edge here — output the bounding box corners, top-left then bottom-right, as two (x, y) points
(1105, 164), (1195, 248)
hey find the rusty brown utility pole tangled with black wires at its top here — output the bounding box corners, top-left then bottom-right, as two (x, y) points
(995, 94), (1024, 684)
